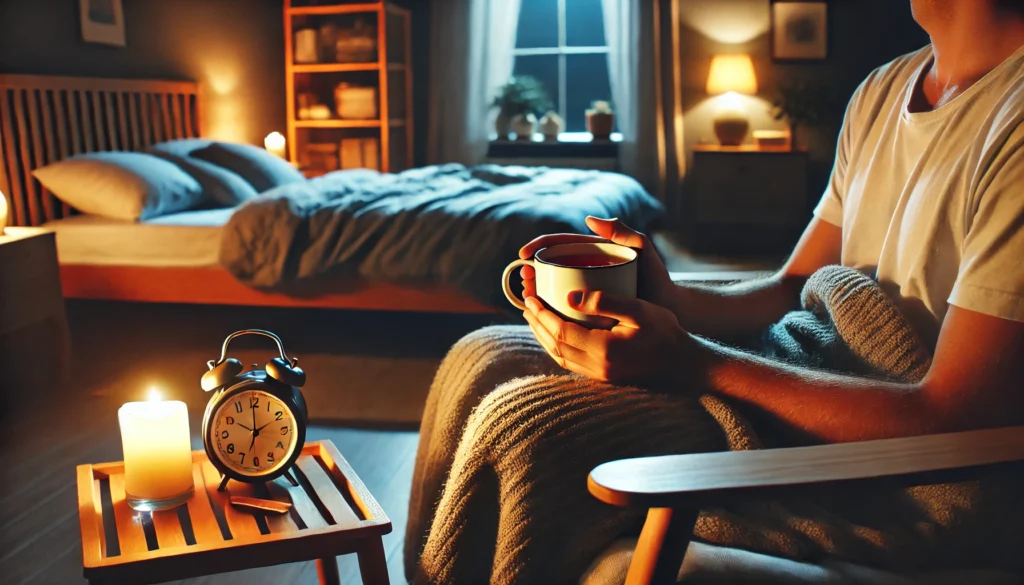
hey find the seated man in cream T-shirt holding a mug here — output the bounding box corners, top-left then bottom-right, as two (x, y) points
(520, 0), (1024, 442)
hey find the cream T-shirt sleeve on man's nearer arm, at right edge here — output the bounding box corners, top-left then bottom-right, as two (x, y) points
(949, 126), (1024, 322)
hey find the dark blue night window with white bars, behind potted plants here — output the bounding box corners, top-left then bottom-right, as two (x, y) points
(513, 0), (611, 132)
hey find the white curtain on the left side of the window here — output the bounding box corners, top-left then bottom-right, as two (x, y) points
(427, 0), (520, 165)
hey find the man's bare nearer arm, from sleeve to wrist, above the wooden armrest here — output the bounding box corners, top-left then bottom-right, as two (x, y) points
(681, 306), (1024, 443)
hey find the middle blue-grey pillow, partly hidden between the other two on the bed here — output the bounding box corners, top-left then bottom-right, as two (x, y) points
(148, 138), (257, 207)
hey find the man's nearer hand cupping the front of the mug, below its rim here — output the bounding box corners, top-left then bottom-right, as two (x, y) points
(523, 291), (696, 383)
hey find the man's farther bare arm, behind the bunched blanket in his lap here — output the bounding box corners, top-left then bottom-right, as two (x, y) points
(657, 217), (843, 339)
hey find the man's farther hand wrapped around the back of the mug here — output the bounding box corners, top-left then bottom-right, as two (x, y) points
(519, 215), (676, 306)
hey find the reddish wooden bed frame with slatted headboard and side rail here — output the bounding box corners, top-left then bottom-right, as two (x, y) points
(0, 75), (498, 314)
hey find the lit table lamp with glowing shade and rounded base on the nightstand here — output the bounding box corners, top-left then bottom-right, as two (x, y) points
(708, 54), (758, 147)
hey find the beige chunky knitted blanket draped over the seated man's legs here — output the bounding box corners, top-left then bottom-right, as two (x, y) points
(404, 266), (1024, 584)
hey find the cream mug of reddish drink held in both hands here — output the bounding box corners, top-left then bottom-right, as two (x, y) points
(502, 242), (637, 329)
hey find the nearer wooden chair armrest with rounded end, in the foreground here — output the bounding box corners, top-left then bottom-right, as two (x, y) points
(587, 426), (1024, 508)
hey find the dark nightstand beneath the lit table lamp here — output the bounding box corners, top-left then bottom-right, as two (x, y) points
(692, 145), (809, 252)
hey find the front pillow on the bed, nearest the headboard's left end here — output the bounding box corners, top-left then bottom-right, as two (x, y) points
(32, 152), (203, 220)
